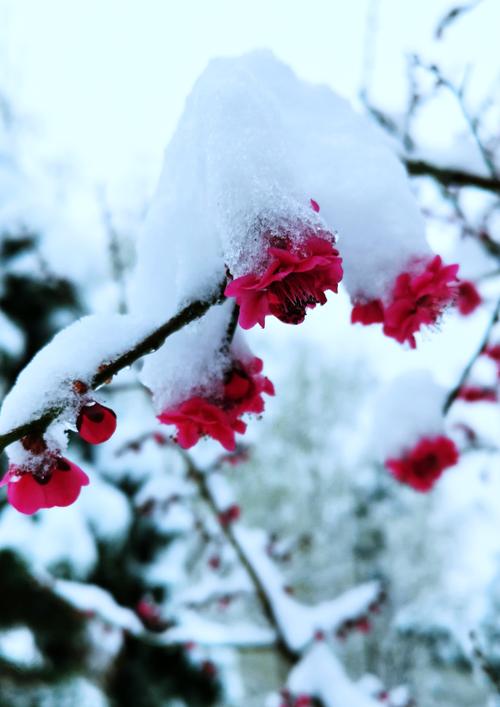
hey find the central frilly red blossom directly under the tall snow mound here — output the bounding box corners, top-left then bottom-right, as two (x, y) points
(225, 234), (343, 329)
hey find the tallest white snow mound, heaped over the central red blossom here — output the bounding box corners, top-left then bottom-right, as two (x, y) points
(131, 51), (428, 317)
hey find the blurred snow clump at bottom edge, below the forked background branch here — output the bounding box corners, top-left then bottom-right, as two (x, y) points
(288, 641), (380, 707)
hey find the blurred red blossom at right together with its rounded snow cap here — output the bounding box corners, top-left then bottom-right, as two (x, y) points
(374, 371), (459, 492)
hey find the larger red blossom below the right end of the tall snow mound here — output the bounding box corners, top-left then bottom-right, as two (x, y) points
(384, 255), (458, 349)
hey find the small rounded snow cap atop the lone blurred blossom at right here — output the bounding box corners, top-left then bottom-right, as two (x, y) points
(369, 370), (446, 461)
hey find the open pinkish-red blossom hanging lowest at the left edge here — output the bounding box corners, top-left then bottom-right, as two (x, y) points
(0, 457), (89, 515)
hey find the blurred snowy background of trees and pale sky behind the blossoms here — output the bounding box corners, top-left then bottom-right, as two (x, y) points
(0, 0), (500, 707)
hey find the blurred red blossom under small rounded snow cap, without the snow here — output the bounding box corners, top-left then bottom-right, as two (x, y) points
(385, 435), (458, 493)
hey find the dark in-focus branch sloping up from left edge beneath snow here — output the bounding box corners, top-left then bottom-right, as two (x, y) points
(0, 279), (226, 452)
